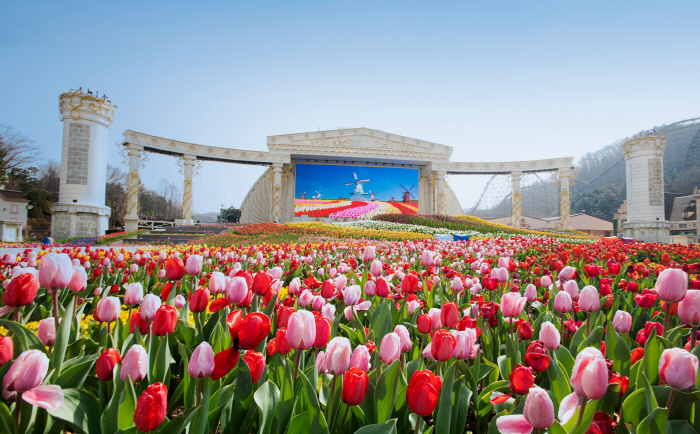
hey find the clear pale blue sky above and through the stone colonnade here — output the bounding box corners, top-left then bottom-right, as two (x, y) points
(0, 0), (700, 212)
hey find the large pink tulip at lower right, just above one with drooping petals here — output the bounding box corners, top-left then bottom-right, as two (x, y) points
(570, 346), (608, 399)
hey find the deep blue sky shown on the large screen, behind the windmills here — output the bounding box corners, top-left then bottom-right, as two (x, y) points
(294, 164), (418, 201)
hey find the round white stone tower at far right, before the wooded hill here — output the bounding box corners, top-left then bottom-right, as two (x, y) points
(622, 134), (671, 243)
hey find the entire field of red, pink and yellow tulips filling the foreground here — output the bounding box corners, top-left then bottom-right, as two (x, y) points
(0, 227), (700, 434)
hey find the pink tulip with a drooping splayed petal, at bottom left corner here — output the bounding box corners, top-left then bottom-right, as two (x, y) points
(2, 350), (63, 410)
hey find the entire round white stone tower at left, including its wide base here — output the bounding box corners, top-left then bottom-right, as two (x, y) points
(51, 89), (111, 239)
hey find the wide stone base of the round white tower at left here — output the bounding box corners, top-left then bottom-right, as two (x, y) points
(51, 203), (111, 240)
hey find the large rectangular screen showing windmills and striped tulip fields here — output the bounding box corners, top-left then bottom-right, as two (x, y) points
(294, 164), (418, 219)
